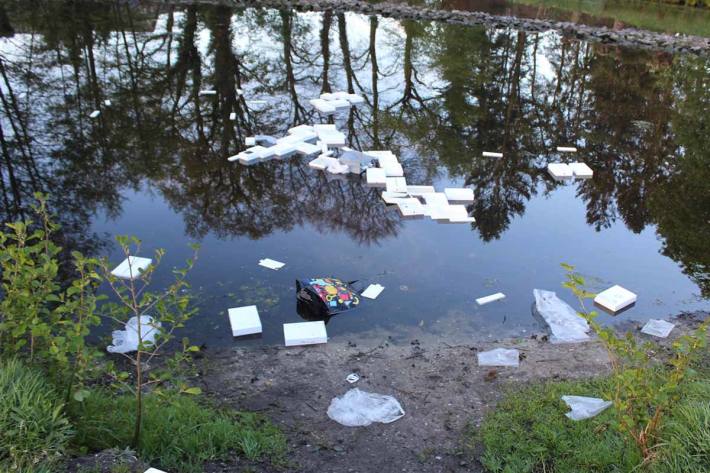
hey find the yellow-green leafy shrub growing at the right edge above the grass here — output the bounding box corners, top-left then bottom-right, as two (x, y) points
(562, 264), (710, 462)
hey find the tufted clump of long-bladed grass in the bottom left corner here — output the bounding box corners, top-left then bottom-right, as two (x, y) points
(0, 360), (72, 473)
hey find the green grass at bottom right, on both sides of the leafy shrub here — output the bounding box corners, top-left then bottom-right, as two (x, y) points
(472, 373), (710, 473)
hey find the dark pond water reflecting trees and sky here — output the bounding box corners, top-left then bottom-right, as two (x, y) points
(0, 2), (710, 346)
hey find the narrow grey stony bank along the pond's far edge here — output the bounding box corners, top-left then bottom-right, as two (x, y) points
(153, 0), (710, 55)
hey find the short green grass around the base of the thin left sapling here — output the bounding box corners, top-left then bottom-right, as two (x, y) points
(72, 391), (286, 473)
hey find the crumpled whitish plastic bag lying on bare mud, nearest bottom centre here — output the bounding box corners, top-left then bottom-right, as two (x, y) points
(328, 388), (404, 427)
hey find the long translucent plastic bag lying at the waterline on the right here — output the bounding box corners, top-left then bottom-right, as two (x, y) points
(533, 289), (589, 343)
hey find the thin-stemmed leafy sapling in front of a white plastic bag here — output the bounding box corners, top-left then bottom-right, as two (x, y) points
(100, 236), (200, 448)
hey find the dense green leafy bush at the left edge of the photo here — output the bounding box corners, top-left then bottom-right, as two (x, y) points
(0, 194), (101, 399)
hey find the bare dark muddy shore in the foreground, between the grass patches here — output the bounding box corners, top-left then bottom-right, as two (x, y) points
(192, 313), (708, 473)
